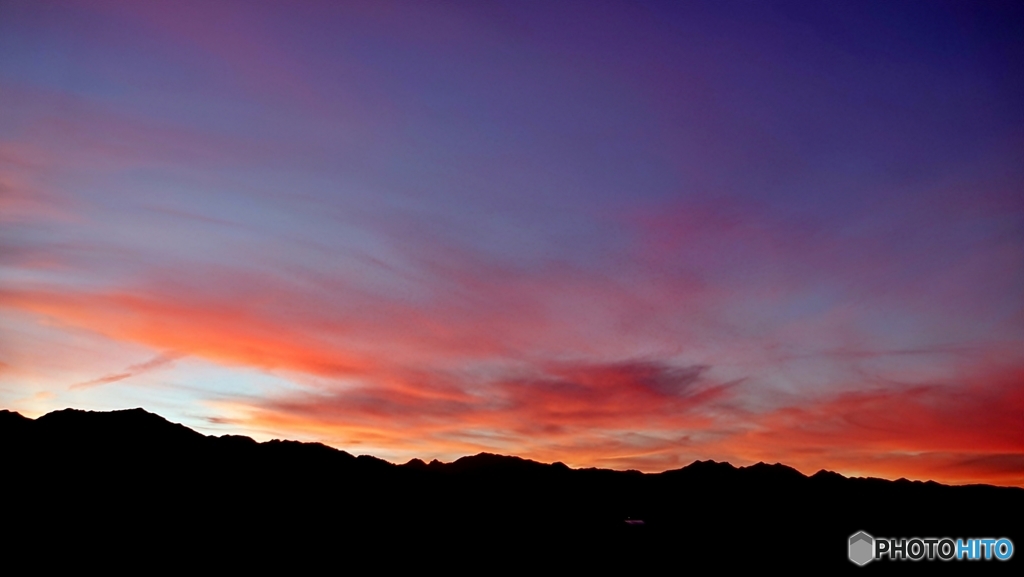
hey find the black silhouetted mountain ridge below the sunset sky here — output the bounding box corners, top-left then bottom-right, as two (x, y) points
(0, 409), (1024, 575)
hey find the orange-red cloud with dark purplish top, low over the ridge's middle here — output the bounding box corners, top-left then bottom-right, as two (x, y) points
(211, 361), (736, 466)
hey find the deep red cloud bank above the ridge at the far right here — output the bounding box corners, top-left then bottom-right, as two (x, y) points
(716, 369), (1024, 486)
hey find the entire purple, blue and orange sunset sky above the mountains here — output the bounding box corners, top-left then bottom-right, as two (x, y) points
(0, 0), (1024, 486)
